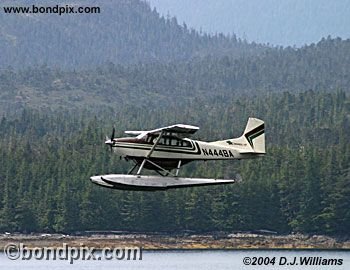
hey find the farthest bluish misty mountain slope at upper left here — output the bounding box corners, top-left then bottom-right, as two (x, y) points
(0, 0), (263, 68)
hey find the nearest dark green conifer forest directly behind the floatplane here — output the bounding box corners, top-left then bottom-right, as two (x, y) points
(0, 91), (350, 235)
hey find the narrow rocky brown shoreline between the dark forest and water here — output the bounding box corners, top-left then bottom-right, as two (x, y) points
(0, 233), (350, 251)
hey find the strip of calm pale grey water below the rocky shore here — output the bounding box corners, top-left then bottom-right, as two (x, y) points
(0, 250), (350, 270)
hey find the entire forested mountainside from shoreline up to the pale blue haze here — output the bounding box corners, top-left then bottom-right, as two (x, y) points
(0, 0), (350, 236)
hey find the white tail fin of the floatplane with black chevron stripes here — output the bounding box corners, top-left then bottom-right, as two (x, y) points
(230, 118), (266, 154)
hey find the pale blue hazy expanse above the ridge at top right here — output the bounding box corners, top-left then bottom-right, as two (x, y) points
(147, 0), (350, 47)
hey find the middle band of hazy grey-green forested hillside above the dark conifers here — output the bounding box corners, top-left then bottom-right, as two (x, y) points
(0, 38), (350, 113)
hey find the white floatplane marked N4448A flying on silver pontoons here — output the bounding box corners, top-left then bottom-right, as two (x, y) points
(90, 118), (266, 191)
